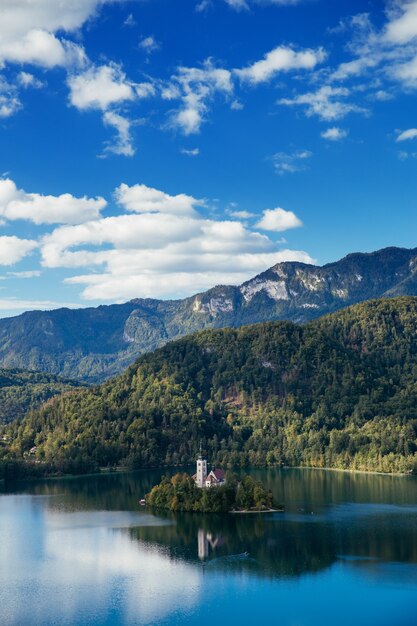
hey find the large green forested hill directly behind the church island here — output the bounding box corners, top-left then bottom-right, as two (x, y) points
(3, 297), (417, 472)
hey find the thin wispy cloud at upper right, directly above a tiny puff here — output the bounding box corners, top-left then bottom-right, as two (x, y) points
(278, 85), (367, 121)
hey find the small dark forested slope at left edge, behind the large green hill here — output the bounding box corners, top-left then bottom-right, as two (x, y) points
(0, 369), (80, 424)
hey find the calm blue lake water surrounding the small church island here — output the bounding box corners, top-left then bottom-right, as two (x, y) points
(0, 470), (417, 626)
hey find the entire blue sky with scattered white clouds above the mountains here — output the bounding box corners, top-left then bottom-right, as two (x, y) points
(0, 0), (417, 316)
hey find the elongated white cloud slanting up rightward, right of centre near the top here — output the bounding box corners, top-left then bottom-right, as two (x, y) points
(235, 46), (326, 85)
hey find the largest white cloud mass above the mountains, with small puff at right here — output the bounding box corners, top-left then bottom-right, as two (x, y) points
(41, 184), (311, 301)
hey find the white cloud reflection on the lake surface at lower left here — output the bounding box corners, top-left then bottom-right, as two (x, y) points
(0, 497), (200, 626)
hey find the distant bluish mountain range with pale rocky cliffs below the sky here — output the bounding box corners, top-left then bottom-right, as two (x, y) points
(0, 248), (417, 382)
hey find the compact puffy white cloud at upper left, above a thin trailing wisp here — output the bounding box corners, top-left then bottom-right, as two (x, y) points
(68, 64), (135, 111)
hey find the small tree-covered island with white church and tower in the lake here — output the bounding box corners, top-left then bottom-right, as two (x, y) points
(145, 451), (280, 513)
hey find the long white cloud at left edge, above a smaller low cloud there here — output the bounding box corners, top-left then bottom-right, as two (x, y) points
(0, 178), (107, 224)
